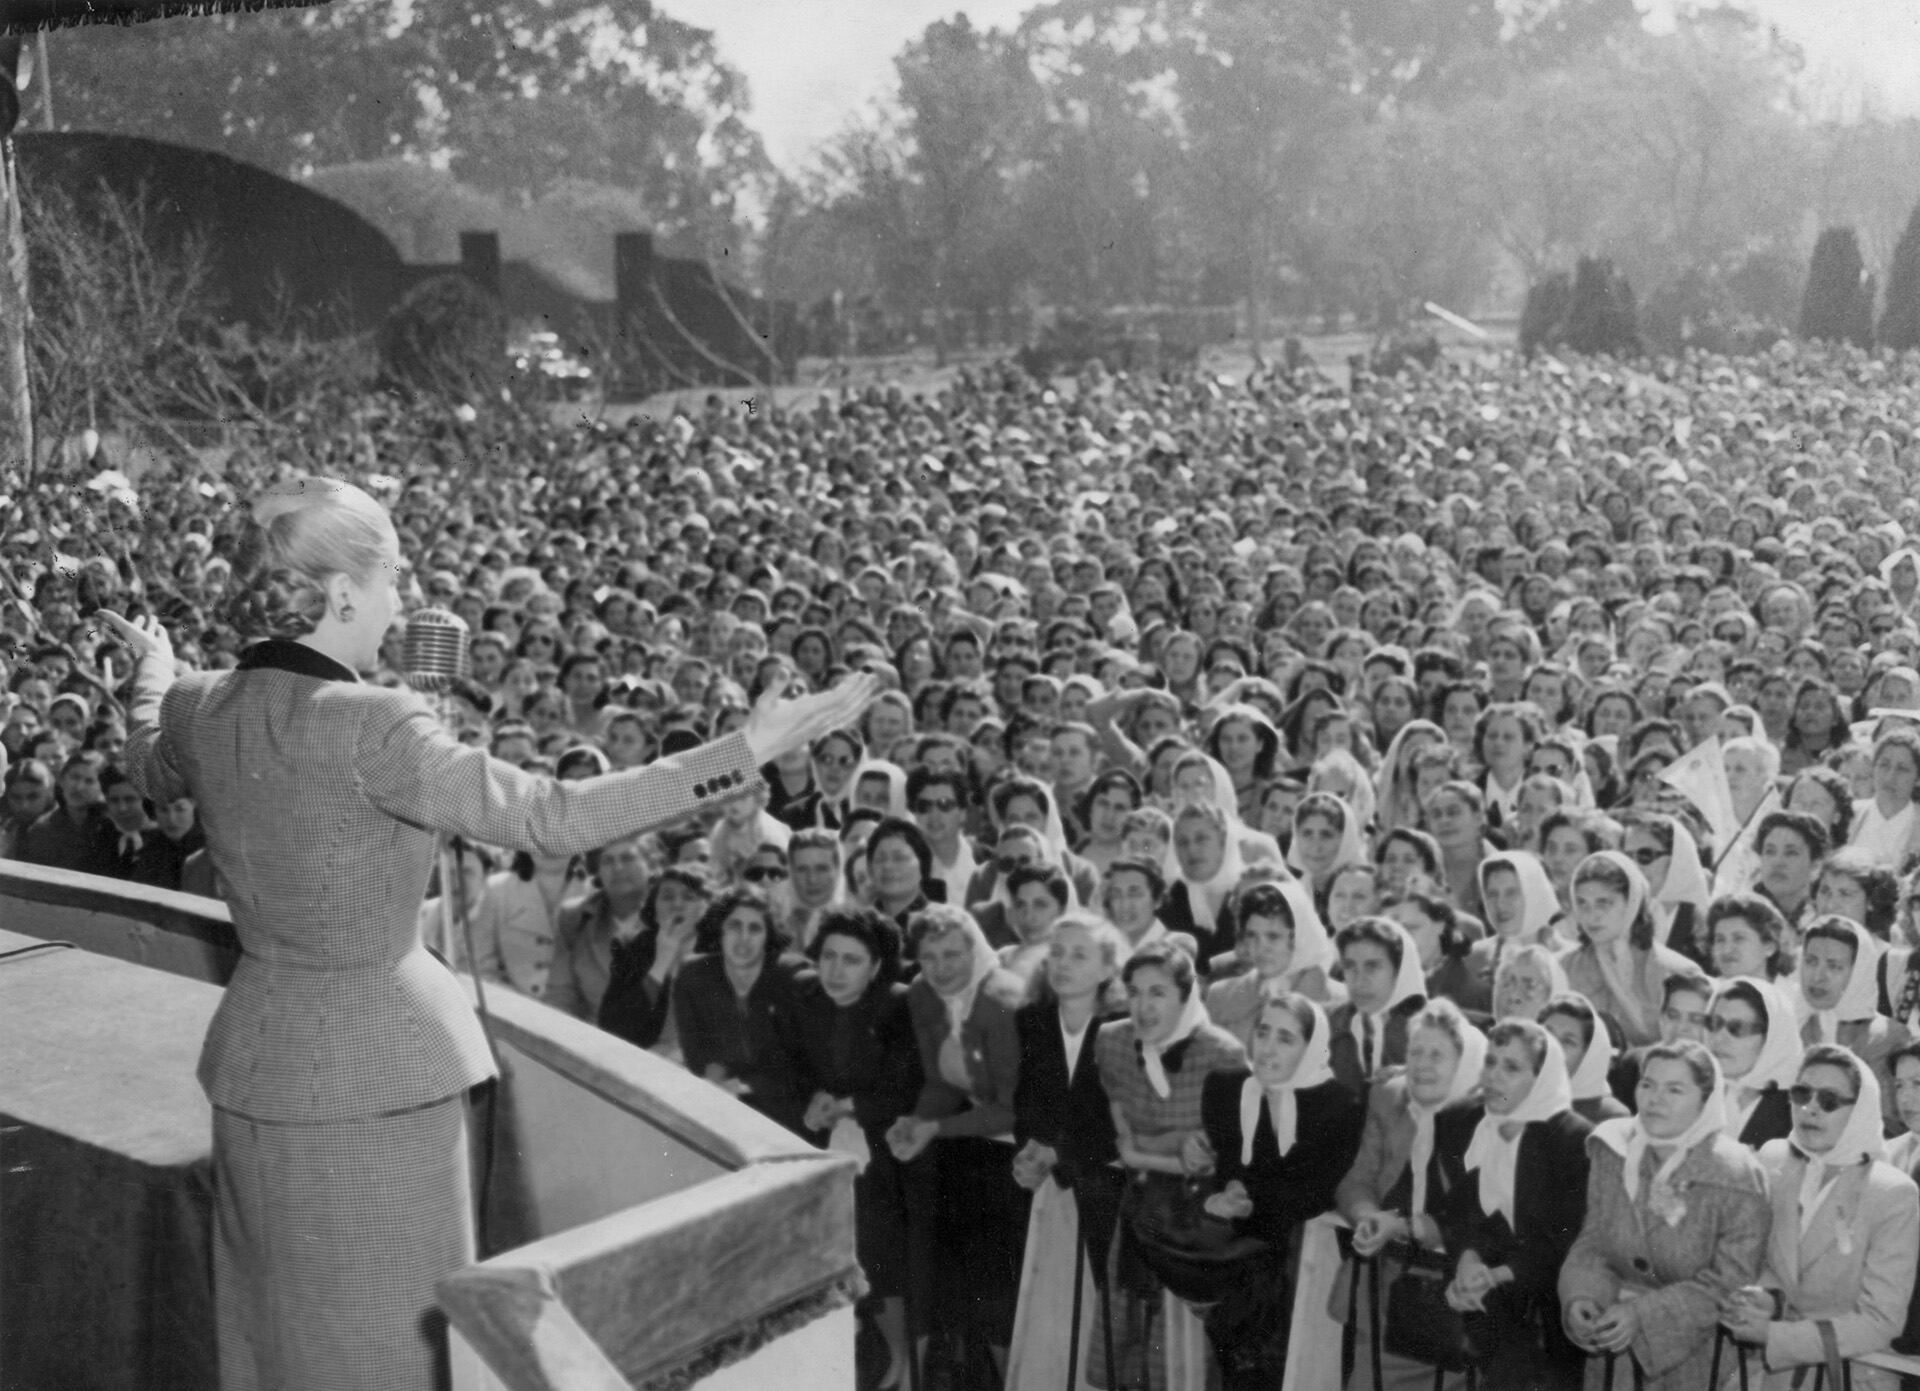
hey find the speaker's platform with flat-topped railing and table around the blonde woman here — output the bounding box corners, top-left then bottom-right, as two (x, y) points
(0, 861), (862, 1391)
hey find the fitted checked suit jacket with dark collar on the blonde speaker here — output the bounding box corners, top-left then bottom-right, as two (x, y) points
(125, 642), (760, 1122)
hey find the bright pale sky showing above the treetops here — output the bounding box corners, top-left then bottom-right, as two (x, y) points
(659, 0), (1920, 171)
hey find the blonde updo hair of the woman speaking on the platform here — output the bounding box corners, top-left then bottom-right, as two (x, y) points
(228, 476), (394, 638)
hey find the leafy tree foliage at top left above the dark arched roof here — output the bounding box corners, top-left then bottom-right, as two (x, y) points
(50, 0), (772, 246)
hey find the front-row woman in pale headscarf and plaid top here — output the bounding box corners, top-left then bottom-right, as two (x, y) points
(1092, 943), (1246, 1391)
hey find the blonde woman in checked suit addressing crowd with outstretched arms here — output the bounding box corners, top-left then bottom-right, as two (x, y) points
(102, 478), (874, 1391)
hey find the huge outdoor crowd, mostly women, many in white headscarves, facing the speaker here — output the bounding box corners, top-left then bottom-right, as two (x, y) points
(0, 336), (1920, 1391)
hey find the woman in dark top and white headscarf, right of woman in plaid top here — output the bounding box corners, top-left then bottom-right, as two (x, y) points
(1190, 993), (1365, 1391)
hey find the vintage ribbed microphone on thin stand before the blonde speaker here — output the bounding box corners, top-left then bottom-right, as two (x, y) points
(399, 609), (507, 1258)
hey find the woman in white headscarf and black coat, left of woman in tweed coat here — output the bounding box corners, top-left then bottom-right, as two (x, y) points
(1434, 1020), (1590, 1387)
